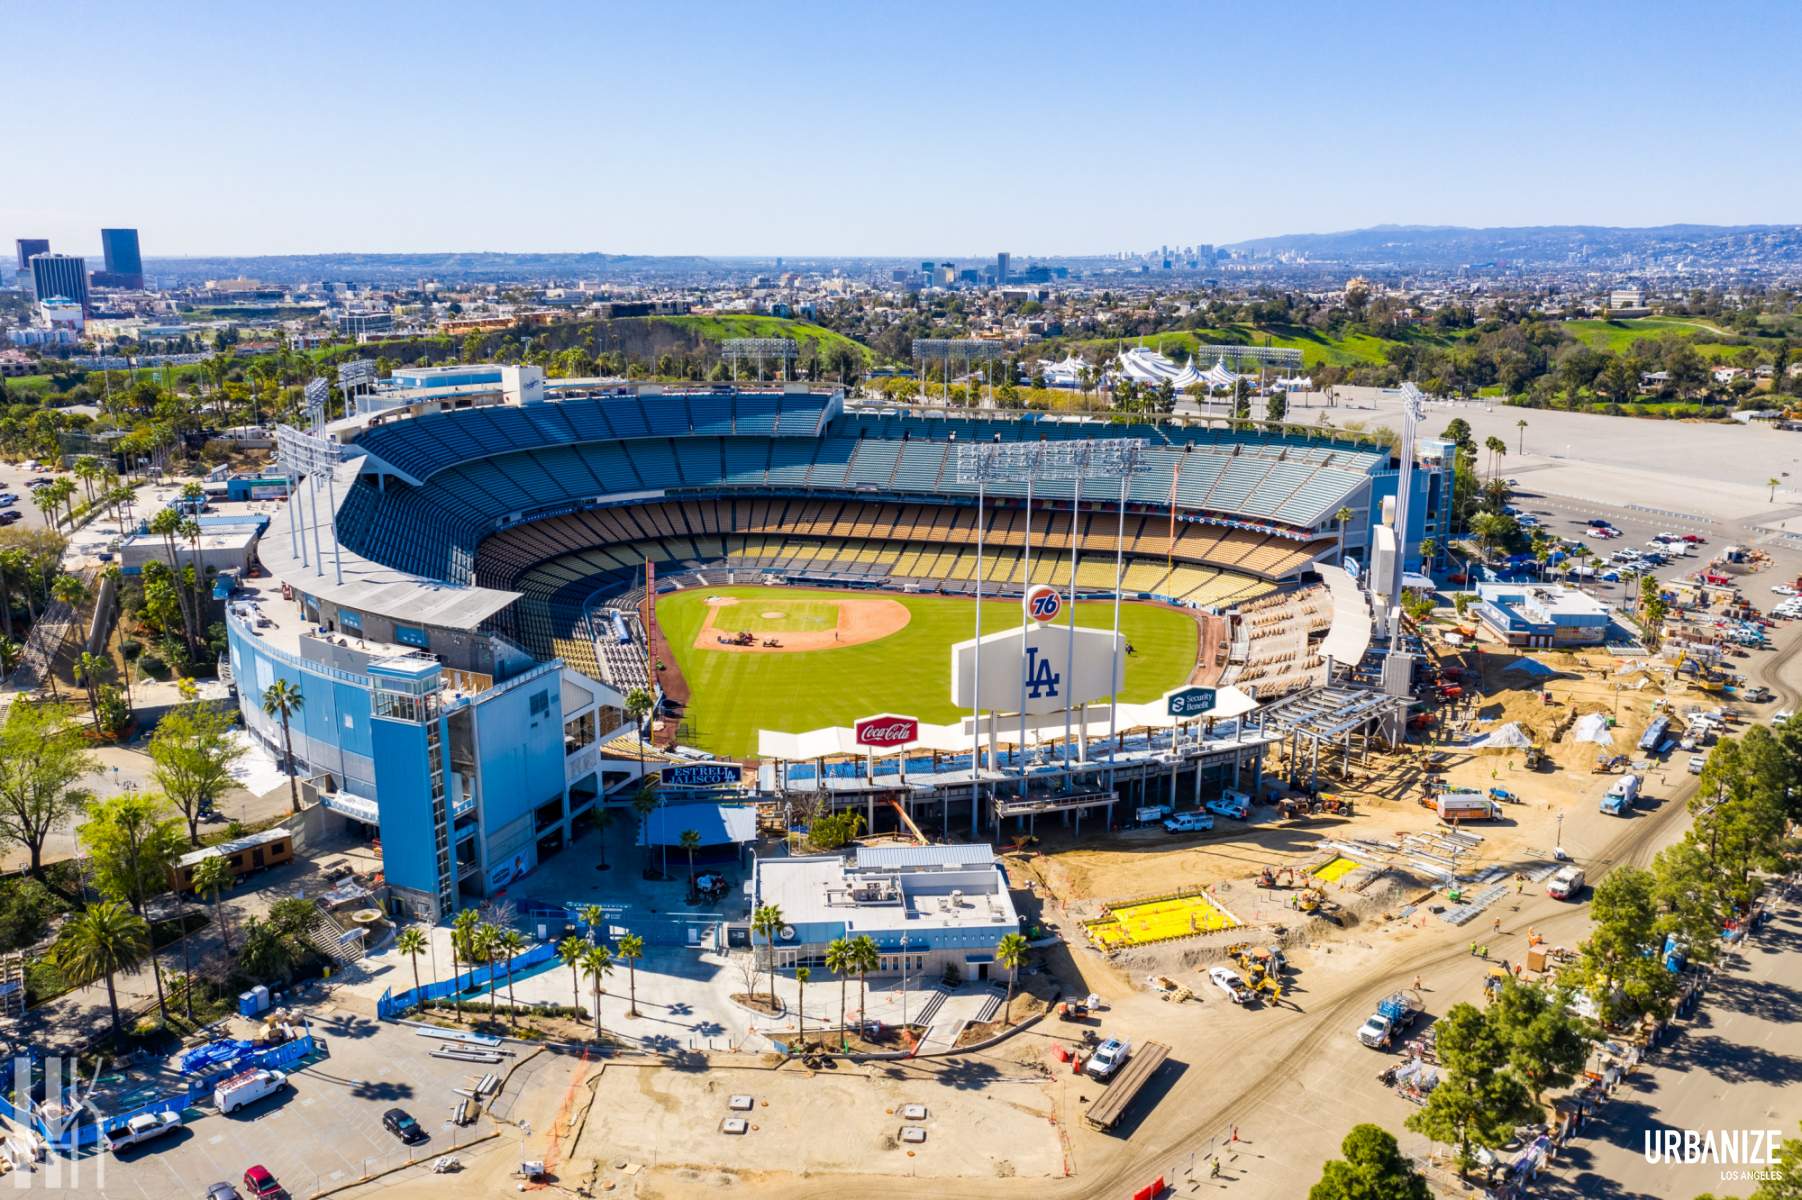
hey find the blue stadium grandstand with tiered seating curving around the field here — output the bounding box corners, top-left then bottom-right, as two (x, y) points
(227, 368), (1452, 917)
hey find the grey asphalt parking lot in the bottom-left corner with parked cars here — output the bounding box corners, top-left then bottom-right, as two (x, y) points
(79, 1005), (517, 1200)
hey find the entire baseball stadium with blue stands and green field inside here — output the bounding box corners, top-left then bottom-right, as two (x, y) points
(227, 368), (1452, 919)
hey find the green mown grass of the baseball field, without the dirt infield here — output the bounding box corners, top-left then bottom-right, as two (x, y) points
(658, 587), (1200, 755)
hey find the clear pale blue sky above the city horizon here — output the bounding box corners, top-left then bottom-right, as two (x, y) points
(14, 0), (1802, 256)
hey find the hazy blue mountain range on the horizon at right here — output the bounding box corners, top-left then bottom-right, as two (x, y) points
(1224, 225), (1802, 268)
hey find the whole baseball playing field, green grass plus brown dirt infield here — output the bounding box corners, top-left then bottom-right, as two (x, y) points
(658, 587), (1200, 755)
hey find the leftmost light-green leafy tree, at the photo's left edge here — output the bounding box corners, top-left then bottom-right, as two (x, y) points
(0, 699), (99, 883)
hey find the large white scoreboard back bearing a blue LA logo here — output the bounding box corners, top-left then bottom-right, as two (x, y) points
(951, 623), (1124, 714)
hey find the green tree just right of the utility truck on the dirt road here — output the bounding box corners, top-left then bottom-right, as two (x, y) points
(1407, 1004), (1532, 1175)
